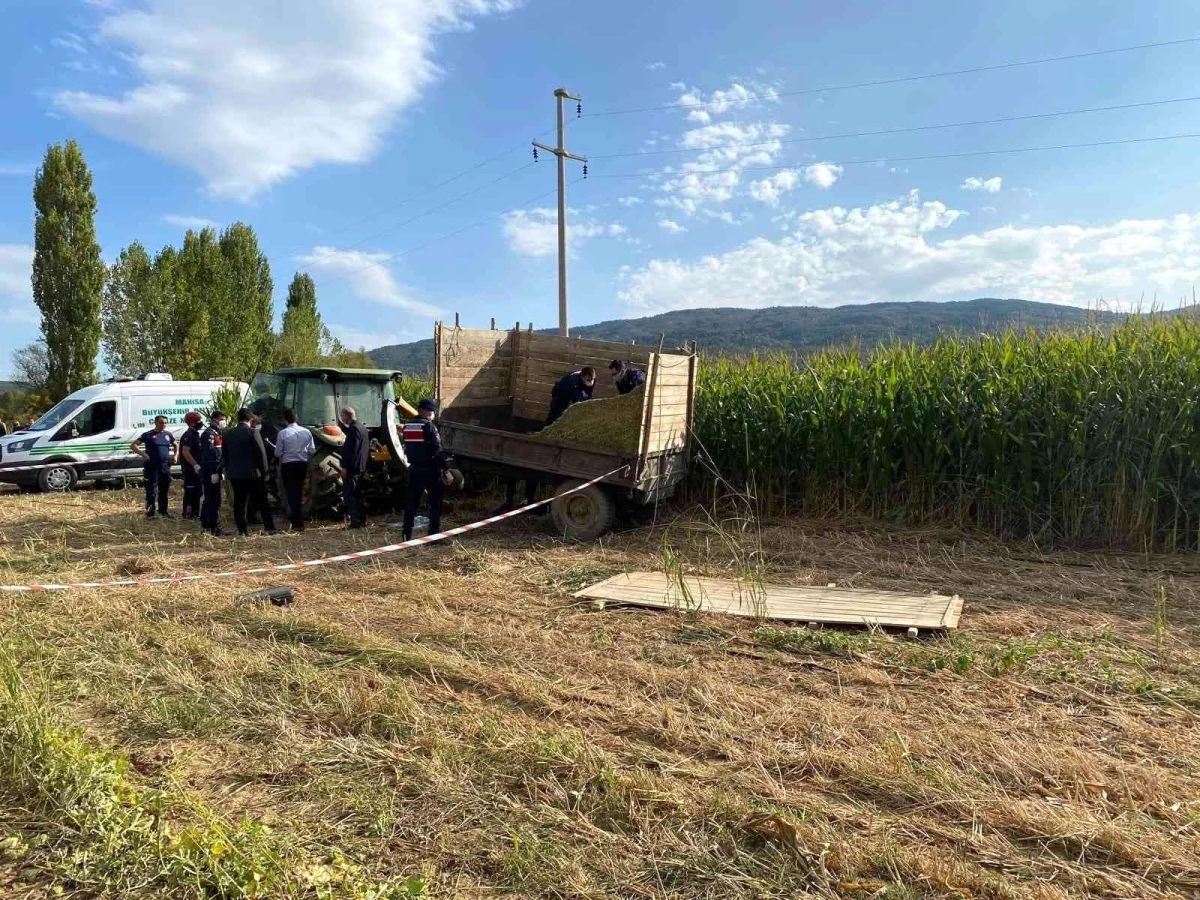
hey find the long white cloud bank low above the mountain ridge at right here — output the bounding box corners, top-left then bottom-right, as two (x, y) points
(619, 192), (1200, 314)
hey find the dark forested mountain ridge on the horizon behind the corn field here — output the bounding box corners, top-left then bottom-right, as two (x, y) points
(368, 298), (1122, 374)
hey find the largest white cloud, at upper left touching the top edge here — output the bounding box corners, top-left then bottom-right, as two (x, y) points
(54, 0), (517, 199)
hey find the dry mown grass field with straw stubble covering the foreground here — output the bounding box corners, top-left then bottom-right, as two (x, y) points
(0, 486), (1200, 900)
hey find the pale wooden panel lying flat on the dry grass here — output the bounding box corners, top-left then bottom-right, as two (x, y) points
(575, 572), (962, 630)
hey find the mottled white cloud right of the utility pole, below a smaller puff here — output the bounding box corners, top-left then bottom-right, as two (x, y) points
(656, 122), (788, 216)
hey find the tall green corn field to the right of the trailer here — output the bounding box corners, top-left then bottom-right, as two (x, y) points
(696, 314), (1200, 550)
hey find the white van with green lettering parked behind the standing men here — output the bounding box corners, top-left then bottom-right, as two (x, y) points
(0, 373), (248, 491)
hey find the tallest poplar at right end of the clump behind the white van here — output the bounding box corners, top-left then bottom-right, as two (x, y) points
(216, 222), (275, 380)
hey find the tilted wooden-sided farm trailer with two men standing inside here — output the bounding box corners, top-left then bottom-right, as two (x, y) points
(433, 322), (697, 540)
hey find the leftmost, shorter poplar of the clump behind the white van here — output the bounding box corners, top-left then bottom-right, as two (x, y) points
(101, 241), (165, 378)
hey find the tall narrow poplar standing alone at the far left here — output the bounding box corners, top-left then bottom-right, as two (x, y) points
(32, 140), (104, 398)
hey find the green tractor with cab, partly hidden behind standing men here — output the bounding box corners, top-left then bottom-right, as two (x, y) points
(250, 366), (416, 517)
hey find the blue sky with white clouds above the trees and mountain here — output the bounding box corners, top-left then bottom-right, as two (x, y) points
(0, 0), (1200, 370)
